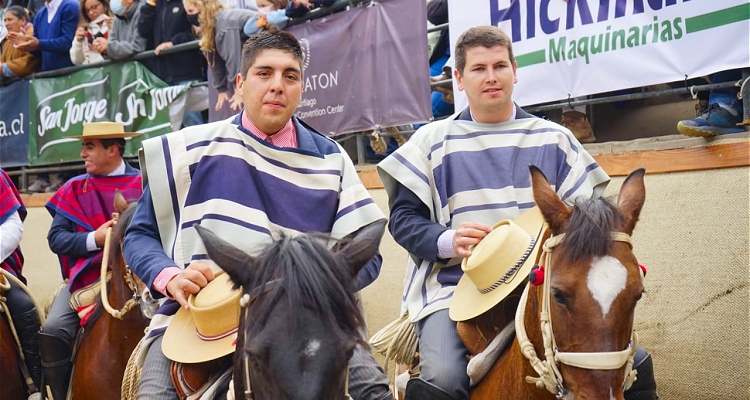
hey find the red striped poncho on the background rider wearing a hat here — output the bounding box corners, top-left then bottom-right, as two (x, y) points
(45, 172), (143, 292)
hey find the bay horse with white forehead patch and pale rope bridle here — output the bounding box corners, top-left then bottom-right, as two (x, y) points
(458, 166), (645, 400)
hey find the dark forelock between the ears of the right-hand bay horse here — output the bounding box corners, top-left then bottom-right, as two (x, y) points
(560, 197), (625, 262)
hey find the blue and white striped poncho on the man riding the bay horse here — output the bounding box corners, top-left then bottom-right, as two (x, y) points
(378, 111), (609, 321)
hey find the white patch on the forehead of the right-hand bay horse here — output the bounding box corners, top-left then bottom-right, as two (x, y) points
(586, 256), (628, 317)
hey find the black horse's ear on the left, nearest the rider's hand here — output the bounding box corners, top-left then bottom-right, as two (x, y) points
(193, 224), (255, 286)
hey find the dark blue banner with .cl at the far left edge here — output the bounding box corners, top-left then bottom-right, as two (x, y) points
(0, 81), (31, 168)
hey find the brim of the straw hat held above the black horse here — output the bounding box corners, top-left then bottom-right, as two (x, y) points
(161, 274), (240, 364)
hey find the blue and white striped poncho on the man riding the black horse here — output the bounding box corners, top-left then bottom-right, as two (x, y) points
(143, 118), (384, 267)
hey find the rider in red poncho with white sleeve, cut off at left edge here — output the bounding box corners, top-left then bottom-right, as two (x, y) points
(0, 169), (41, 396)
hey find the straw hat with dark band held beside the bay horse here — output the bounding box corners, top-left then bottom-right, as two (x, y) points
(449, 207), (546, 321)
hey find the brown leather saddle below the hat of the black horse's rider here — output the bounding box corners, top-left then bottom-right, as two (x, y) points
(170, 354), (232, 400)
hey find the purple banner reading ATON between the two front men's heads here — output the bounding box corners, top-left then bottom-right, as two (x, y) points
(220, 0), (432, 136)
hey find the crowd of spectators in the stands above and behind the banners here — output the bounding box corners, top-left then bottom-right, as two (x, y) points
(0, 0), (743, 192)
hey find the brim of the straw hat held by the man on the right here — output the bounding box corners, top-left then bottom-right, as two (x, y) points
(449, 207), (547, 321)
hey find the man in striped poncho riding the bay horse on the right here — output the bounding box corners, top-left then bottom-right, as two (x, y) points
(378, 27), (609, 400)
